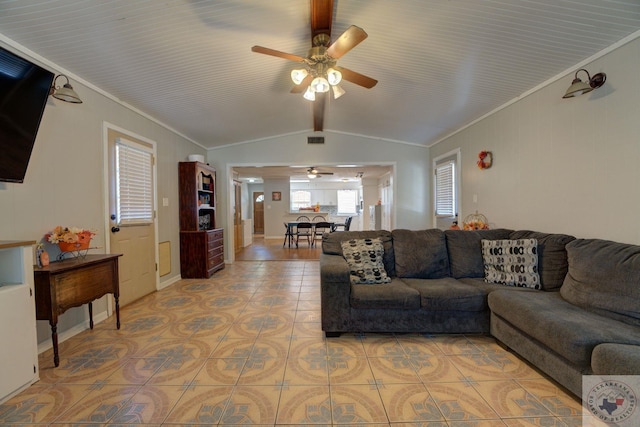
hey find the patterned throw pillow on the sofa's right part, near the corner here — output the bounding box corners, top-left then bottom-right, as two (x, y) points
(482, 239), (541, 289)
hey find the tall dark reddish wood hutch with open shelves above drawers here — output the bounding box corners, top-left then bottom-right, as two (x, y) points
(178, 162), (224, 278)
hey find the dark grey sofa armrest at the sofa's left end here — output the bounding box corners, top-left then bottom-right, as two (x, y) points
(320, 253), (351, 333)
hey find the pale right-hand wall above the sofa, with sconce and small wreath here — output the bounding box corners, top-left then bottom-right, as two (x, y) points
(431, 39), (640, 244)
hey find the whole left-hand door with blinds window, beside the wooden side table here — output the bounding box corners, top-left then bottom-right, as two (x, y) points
(106, 127), (159, 305)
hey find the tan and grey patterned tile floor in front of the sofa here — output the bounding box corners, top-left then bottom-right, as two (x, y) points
(0, 261), (592, 427)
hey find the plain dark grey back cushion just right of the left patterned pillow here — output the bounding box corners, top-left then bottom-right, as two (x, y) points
(391, 228), (449, 279)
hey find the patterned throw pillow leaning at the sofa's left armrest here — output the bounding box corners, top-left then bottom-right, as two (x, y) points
(341, 238), (391, 285)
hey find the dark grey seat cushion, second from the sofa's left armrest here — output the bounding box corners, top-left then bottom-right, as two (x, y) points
(402, 277), (487, 311)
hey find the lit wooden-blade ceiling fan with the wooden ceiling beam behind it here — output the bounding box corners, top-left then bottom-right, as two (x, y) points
(251, 0), (378, 131)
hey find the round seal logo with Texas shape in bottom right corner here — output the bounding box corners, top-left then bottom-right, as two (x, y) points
(585, 380), (638, 425)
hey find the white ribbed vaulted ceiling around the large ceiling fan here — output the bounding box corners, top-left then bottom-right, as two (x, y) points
(0, 0), (640, 148)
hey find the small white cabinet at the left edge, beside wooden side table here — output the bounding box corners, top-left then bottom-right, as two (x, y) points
(0, 241), (38, 403)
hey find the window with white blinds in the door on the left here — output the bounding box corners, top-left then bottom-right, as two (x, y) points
(115, 138), (153, 225)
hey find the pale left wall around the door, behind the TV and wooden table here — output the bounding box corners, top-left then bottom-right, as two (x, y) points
(0, 40), (204, 343)
